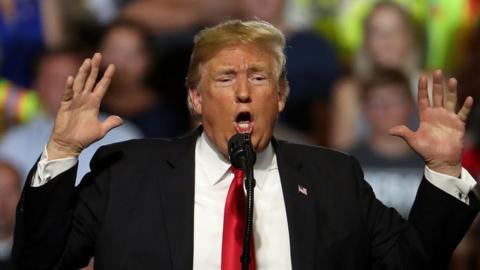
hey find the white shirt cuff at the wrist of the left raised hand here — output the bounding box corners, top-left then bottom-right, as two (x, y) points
(30, 146), (78, 187)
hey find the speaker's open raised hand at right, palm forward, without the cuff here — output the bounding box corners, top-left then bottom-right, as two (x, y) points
(390, 70), (473, 177)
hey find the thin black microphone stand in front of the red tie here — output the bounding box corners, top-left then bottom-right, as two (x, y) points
(240, 166), (255, 270)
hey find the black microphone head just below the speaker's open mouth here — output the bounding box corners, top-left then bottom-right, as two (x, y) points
(228, 133), (257, 171)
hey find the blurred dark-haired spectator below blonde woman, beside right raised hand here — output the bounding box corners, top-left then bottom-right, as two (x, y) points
(349, 70), (423, 218)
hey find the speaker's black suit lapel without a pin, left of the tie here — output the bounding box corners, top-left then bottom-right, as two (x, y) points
(155, 129), (201, 270)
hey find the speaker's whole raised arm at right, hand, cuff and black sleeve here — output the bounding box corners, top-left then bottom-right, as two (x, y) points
(360, 70), (478, 269)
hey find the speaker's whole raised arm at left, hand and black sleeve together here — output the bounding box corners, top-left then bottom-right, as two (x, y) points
(12, 53), (122, 269)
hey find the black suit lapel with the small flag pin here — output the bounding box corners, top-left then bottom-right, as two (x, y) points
(273, 140), (316, 270)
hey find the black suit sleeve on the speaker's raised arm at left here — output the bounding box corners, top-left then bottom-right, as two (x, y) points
(12, 147), (113, 270)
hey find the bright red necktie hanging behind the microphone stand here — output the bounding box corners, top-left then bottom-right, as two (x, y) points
(222, 166), (255, 270)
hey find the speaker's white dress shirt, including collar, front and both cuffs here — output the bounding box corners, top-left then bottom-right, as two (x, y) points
(32, 133), (476, 270)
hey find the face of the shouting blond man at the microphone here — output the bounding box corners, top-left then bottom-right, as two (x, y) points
(189, 45), (285, 157)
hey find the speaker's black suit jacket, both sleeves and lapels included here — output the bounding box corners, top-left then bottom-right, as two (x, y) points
(13, 131), (477, 270)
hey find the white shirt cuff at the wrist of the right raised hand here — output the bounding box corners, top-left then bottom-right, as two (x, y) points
(425, 166), (477, 205)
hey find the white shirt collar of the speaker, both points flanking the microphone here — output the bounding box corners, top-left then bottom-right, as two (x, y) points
(197, 132), (277, 189)
